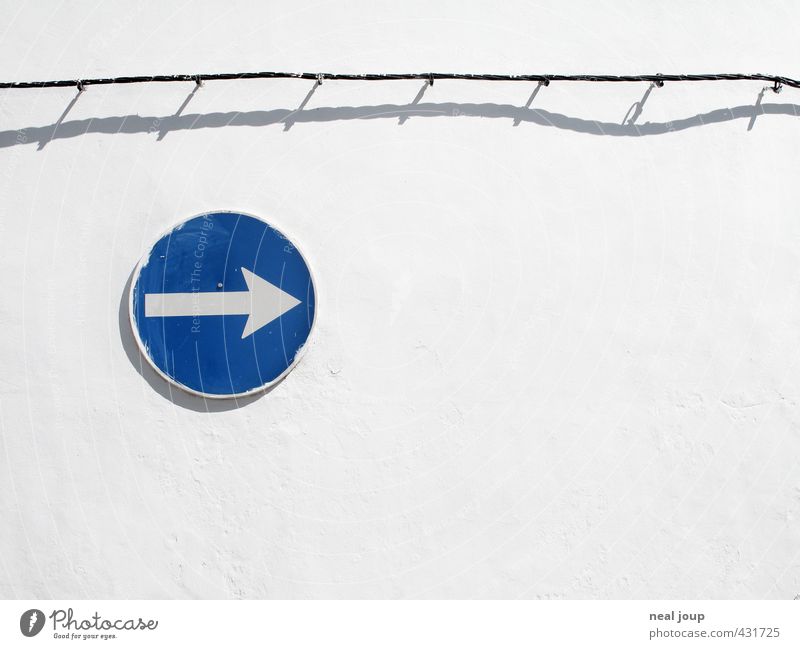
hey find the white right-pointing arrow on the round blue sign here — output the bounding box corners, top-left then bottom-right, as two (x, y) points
(144, 268), (300, 338)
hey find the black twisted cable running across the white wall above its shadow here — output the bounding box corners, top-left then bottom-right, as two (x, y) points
(0, 72), (800, 92)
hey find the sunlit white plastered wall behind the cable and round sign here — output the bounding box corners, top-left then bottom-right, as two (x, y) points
(0, 0), (800, 598)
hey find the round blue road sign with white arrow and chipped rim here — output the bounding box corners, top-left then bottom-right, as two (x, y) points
(130, 212), (316, 398)
